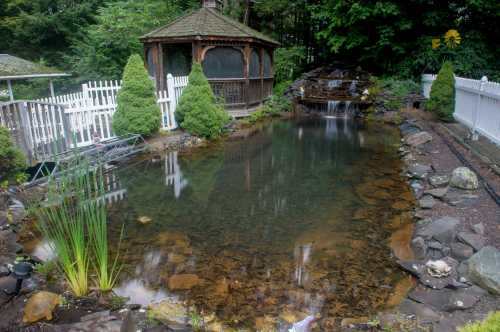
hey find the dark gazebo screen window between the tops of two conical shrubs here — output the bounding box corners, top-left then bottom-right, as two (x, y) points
(163, 44), (192, 76)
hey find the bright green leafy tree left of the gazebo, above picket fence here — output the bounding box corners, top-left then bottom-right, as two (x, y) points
(66, 0), (190, 79)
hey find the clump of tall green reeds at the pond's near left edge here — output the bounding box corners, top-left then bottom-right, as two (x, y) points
(35, 158), (119, 296)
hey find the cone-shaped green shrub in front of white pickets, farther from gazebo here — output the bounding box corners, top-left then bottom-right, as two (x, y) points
(113, 54), (161, 136)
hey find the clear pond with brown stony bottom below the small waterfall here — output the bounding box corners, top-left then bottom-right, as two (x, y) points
(30, 118), (413, 330)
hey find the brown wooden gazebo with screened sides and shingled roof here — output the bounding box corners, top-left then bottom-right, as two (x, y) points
(141, 0), (279, 115)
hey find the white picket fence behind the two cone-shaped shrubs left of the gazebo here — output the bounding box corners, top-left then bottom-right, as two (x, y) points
(39, 74), (188, 147)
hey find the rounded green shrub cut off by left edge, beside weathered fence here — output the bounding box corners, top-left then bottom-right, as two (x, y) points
(0, 126), (26, 182)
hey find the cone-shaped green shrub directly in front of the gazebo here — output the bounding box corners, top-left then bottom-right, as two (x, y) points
(175, 63), (230, 139)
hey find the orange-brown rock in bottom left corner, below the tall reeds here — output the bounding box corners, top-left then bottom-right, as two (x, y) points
(23, 291), (61, 324)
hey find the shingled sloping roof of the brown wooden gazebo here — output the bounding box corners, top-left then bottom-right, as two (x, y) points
(141, 7), (279, 46)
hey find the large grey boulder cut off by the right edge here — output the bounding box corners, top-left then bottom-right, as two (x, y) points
(467, 246), (500, 295)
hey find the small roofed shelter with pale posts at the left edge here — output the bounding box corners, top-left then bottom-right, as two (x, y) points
(0, 54), (70, 101)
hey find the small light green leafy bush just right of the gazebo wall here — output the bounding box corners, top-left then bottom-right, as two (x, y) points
(273, 46), (306, 83)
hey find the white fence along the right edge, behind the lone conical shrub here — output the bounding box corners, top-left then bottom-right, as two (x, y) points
(422, 75), (500, 145)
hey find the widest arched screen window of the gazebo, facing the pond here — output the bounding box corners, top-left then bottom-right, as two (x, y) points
(203, 47), (243, 78)
